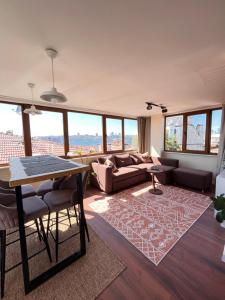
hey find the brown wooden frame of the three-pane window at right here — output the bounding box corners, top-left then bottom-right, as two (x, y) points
(164, 107), (222, 155)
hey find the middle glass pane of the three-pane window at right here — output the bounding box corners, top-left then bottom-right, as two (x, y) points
(187, 114), (206, 151)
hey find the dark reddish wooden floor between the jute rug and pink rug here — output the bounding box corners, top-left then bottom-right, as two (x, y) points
(85, 190), (225, 300)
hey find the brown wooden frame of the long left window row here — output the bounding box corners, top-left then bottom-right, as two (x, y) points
(0, 100), (137, 167)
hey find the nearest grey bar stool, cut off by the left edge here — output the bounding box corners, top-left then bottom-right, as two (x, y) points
(0, 194), (52, 298)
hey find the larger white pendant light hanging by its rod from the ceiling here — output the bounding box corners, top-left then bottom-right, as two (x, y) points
(40, 48), (67, 104)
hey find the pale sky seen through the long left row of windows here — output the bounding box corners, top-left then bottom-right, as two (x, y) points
(0, 103), (137, 136)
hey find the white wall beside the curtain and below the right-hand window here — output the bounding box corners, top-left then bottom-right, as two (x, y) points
(151, 115), (217, 176)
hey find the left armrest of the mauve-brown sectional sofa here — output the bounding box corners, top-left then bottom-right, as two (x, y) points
(92, 162), (113, 193)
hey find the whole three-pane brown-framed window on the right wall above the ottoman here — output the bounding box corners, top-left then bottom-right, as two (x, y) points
(165, 109), (222, 154)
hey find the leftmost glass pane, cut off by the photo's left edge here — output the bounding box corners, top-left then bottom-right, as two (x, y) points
(0, 103), (25, 164)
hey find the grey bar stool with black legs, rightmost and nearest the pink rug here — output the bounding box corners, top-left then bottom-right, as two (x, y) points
(43, 172), (90, 262)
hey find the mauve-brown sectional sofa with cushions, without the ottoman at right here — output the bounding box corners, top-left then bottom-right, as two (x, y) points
(91, 154), (179, 193)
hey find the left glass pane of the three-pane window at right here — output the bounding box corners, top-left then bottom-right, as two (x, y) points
(165, 115), (183, 151)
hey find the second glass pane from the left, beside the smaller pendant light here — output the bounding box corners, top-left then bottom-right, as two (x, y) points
(30, 111), (65, 156)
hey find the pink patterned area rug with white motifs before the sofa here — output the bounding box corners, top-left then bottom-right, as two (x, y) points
(89, 183), (211, 265)
